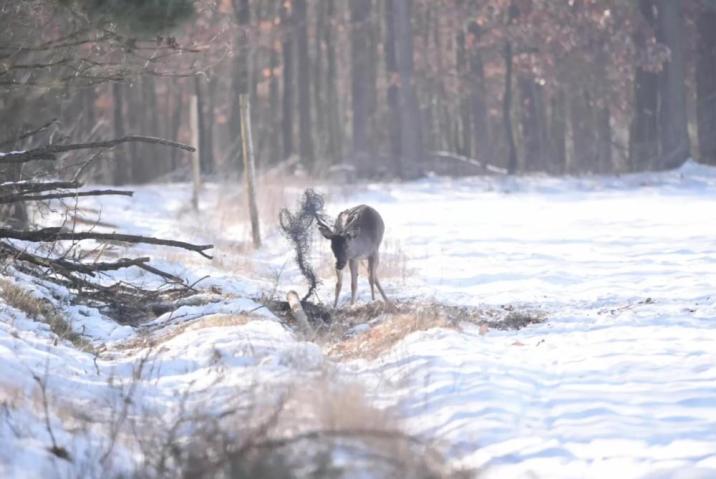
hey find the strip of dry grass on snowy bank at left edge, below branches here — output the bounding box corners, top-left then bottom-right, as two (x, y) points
(0, 279), (93, 352)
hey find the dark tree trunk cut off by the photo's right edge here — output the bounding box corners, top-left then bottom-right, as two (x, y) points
(696, 2), (716, 166)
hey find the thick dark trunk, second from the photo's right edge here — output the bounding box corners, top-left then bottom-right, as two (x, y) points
(657, 0), (690, 169)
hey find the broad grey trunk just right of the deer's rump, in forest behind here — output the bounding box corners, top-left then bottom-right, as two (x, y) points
(392, 0), (424, 178)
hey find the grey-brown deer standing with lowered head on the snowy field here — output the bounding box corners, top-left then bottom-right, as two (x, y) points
(316, 205), (390, 309)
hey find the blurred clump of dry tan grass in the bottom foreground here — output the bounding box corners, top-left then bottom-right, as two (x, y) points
(128, 377), (467, 479)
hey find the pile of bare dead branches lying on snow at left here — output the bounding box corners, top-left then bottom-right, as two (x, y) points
(0, 125), (213, 323)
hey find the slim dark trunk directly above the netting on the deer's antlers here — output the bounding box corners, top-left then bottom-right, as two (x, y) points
(294, 0), (314, 170)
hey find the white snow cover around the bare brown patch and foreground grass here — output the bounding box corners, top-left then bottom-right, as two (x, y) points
(0, 163), (716, 478)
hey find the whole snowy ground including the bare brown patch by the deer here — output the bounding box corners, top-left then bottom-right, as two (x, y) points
(0, 163), (716, 478)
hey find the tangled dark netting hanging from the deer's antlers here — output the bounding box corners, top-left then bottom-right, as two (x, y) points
(279, 189), (326, 301)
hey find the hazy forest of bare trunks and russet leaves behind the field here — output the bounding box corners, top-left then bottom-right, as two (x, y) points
(0, 0), (716, 185)
